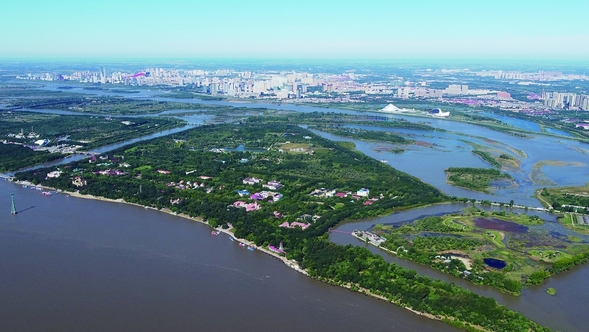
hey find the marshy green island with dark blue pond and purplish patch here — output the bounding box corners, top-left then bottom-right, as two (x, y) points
(373, 207), (589, 295)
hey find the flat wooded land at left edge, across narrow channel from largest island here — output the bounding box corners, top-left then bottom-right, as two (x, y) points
(0, 111), (186, 172)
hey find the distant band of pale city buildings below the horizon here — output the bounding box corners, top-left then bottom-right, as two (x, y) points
(17, 67), (589, 111)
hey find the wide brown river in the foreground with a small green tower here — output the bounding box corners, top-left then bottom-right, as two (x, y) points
(0, 180), (456, 331)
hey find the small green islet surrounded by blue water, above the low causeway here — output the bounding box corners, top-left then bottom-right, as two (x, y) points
(445, 167), (513, 193)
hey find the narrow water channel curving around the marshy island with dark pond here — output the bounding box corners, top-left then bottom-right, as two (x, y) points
(329, 204), (589, 331)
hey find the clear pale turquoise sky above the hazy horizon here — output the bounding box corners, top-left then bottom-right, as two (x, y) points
(0, 0), (589, 60)
